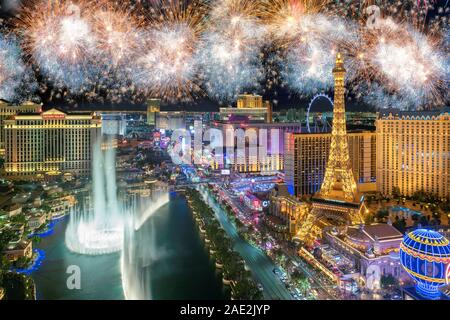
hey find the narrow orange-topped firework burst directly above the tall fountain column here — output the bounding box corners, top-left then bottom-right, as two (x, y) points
(89, 1), (144, 102)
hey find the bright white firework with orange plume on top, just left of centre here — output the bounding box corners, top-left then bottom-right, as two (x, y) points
(134, 1), (205, 101)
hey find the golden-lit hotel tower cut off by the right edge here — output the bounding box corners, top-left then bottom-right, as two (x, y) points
(376, 108), (450, 198)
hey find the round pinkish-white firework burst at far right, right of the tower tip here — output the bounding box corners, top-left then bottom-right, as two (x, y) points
(368, 23), (449, 107)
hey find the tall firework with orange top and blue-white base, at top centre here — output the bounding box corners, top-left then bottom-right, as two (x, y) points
(197, 0), (266, 102)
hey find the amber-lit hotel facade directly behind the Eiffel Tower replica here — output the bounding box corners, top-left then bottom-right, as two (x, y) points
(284, 131), (376, 197)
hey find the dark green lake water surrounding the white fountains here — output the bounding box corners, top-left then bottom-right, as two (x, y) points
(32, 195), (224, 300)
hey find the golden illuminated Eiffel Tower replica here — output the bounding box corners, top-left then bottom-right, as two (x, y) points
(312, 53), (364, 224)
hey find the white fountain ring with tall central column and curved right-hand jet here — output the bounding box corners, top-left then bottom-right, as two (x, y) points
(65, 139), (169, 256)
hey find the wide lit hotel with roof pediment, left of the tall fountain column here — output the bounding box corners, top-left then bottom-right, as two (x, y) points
(4, 109), (101, 179)
